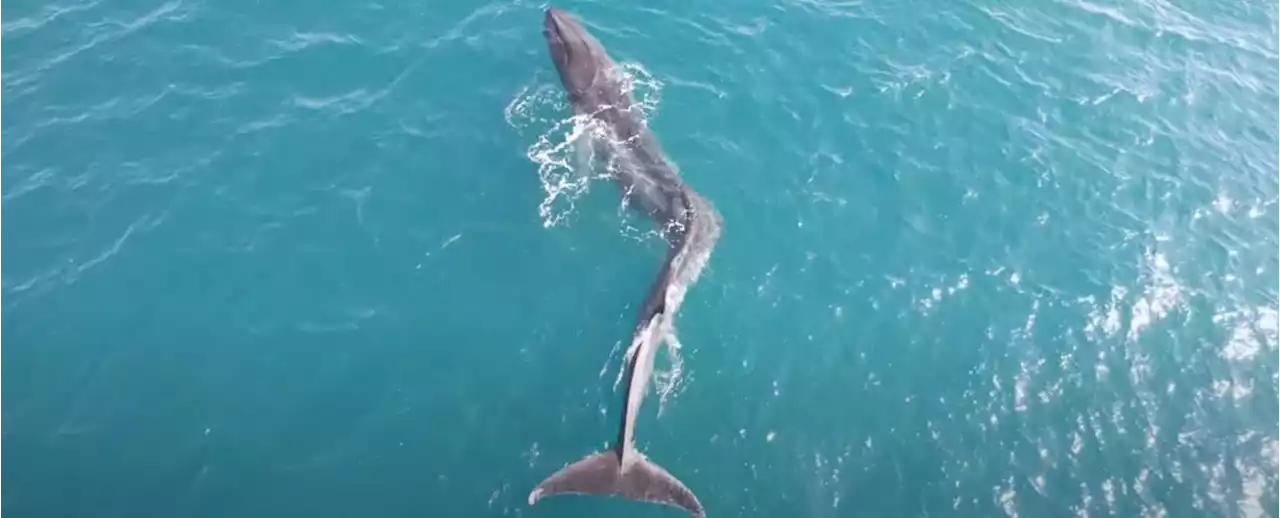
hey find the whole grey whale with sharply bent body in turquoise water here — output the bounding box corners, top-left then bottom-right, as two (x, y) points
(529, 8), (721, 518)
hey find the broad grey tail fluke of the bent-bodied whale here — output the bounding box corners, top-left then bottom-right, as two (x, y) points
(529, 450), (707, 518)
